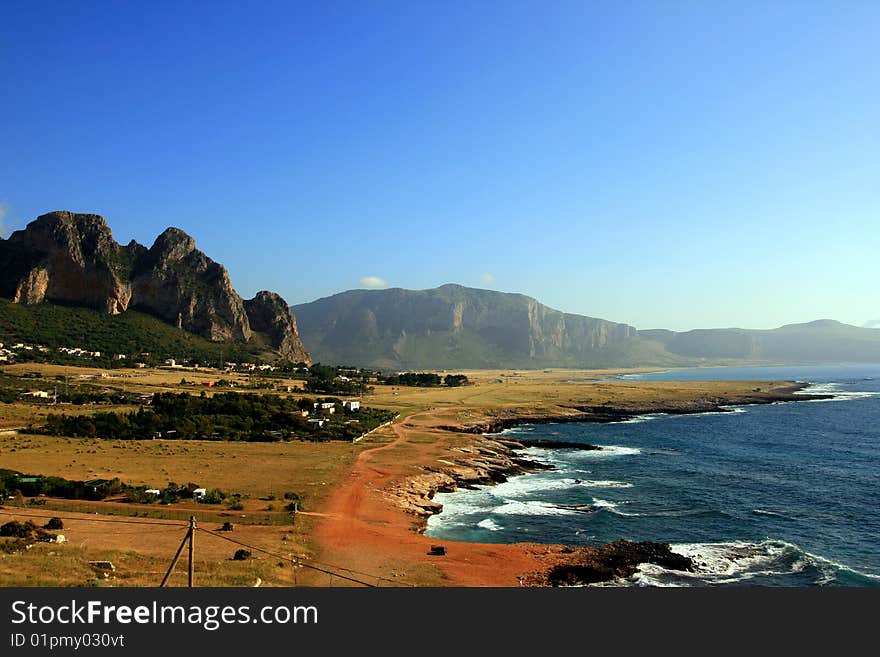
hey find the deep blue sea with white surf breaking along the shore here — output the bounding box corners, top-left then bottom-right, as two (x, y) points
(426, 365), (880, 586)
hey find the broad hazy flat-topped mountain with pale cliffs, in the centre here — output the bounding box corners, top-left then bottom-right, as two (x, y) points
(293, 285), (636, 369)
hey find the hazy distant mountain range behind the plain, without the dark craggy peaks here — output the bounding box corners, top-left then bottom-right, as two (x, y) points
(292, 285), (880, 369)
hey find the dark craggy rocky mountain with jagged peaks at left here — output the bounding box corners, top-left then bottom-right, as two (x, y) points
(0, 211), (309, 362)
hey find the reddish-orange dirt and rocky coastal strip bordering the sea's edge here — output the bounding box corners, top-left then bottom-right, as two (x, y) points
(313, 371), (828, 587)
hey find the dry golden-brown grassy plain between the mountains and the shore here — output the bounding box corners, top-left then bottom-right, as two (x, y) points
(0, 364), (792, 586)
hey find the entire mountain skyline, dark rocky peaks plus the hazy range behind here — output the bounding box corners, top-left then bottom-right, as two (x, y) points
(0, 211), (880, 370)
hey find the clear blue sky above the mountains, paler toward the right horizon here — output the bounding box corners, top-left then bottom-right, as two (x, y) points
(0, 0), (880, 330)
